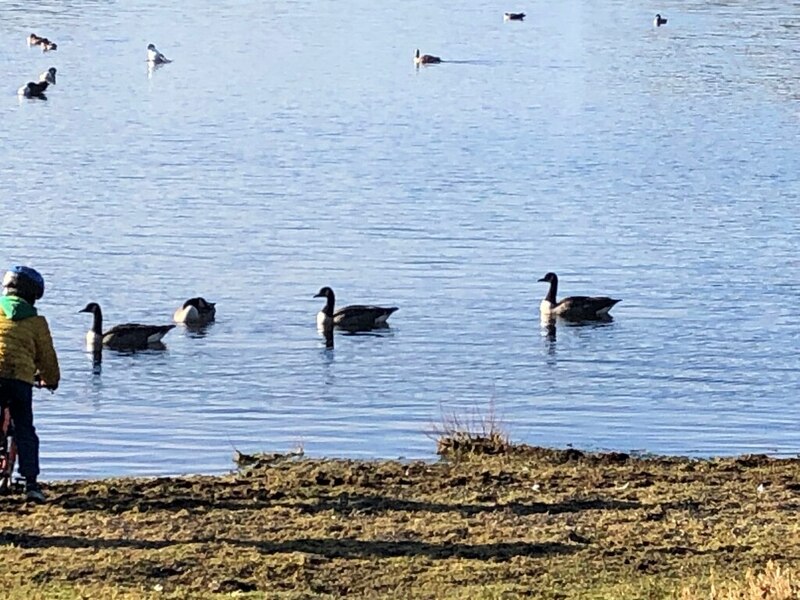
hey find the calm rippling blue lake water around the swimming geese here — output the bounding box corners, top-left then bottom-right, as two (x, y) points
(0, 0), (800, 479)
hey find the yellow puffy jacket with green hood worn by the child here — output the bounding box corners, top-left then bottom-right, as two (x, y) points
(0, 296), (61, 388)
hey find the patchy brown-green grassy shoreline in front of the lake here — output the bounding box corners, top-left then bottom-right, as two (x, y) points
(0, 445), (800, 600)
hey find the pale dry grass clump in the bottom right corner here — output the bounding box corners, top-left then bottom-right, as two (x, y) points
(680, 561), (800, 600)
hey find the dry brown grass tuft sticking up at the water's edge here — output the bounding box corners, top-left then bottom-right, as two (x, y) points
(432, 403), (512, 458)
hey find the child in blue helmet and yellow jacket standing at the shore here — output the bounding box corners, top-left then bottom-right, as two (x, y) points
(0, 267), (61, 502)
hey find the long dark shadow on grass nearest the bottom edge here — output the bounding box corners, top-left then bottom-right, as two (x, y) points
(0, 532), (580, 560)
